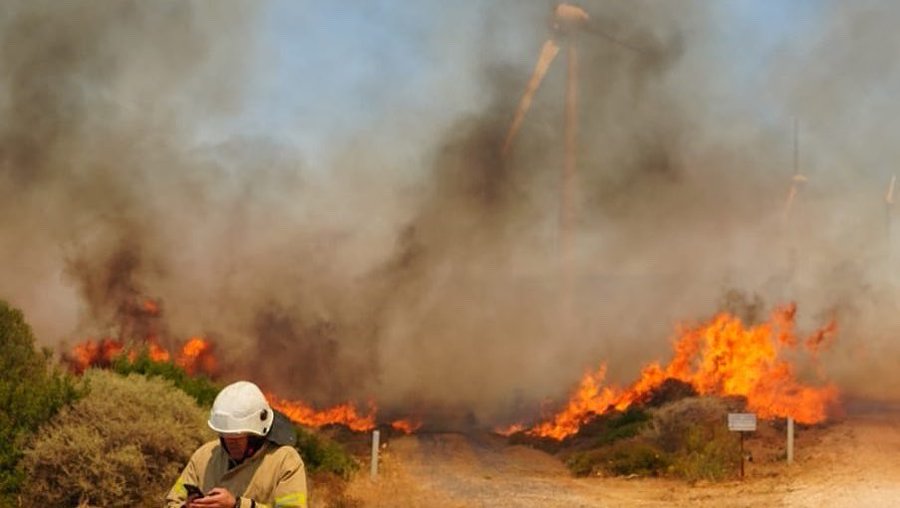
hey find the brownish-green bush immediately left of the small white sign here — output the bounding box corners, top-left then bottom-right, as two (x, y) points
(647, 397), (741, 481)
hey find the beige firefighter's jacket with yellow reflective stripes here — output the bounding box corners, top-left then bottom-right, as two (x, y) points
(166, 440), (307, 508)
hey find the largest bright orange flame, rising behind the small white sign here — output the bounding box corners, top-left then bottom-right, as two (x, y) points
(524, 304), (838, 440)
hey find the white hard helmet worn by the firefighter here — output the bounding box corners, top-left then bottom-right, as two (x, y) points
(208, 381), (274, 436)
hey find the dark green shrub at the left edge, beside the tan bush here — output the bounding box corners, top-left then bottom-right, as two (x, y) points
(0, 300), (80, 506)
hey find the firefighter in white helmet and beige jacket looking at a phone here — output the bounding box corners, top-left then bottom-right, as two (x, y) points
(166, 381), (307, 508)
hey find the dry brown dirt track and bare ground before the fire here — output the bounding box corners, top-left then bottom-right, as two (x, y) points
(347, 404), (900, 508)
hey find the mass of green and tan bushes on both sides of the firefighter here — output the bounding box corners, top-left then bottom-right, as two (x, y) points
(0, 300), (359, 508)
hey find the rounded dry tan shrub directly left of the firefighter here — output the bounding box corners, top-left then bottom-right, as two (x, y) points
(22, 370), (213, 507)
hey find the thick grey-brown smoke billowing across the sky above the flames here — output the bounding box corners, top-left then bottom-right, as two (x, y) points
(0, 0), (900, 423)
